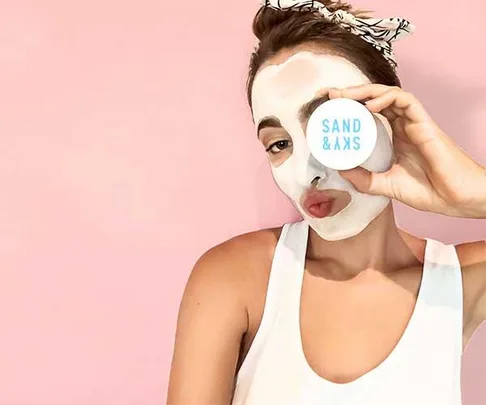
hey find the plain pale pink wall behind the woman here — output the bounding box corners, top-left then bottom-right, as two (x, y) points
(0, 0), (486, 405)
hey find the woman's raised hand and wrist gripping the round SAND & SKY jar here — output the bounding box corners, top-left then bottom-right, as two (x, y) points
(329, 84), (486, 218)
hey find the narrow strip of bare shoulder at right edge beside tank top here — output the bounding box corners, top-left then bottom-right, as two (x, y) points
(455, 241), (486, 329)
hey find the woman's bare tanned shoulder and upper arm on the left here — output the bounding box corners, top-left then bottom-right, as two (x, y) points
(167, 229), (280, 405)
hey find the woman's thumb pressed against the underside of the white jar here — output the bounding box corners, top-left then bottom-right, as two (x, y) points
(339, 167), (393, 198)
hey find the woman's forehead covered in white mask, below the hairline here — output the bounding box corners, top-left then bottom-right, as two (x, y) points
(252, 51), (369, 124)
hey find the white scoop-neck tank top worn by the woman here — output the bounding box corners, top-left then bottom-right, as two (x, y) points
(232, 221), (463, 405)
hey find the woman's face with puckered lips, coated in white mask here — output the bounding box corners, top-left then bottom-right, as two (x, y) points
(252, 49), (393, 240)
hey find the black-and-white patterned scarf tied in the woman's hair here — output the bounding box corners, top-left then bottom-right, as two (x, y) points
(261, 0), (415, 70)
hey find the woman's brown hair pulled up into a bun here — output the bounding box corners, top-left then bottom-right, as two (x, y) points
(247, 0), (401, 107)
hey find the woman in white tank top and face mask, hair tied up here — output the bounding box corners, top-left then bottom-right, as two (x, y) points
(168, 1), (486, 405)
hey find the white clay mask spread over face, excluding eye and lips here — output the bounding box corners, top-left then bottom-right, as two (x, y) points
(252, 52), (393, 241)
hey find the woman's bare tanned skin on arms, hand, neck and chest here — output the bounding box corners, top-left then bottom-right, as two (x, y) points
(167, 47), (486, 405)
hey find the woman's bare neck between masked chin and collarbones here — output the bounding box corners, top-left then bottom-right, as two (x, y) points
(307, 204), (421, 275)
